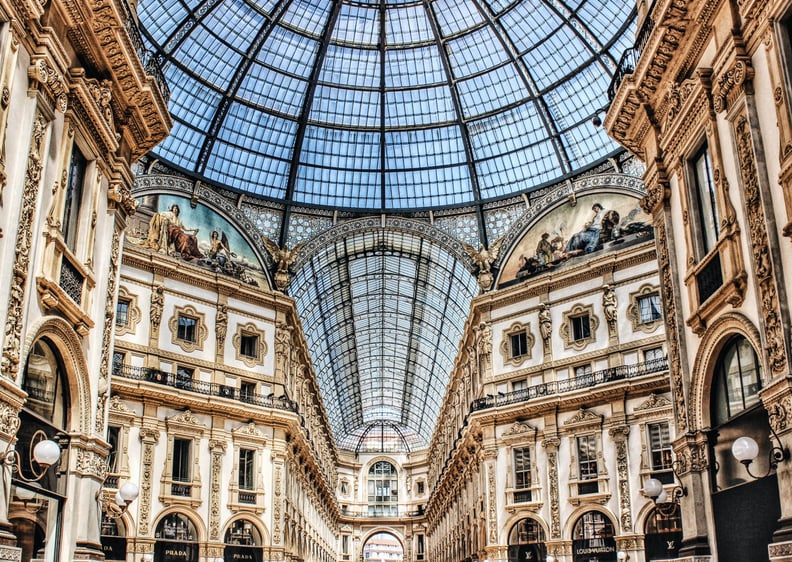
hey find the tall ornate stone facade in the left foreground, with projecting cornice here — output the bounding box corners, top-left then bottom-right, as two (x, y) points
(0, 0), (171, 561)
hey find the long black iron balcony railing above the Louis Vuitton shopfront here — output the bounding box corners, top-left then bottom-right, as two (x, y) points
(470, 358), (668, 412)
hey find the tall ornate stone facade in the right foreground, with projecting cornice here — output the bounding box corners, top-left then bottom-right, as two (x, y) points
(605, 1), (792, 561)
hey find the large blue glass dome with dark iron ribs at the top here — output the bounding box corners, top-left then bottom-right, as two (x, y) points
(138, 0), (635, 212)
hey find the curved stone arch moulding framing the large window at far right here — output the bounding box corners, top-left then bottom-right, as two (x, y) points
(688, 312), (770, 431)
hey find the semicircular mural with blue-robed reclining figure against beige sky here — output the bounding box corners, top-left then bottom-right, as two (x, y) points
(499, 193), (654, 286)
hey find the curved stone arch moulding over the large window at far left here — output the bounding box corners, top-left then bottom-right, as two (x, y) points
(22, 316), (93, 434)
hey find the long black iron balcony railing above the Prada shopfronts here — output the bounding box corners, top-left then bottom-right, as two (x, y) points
(113, 365), (297, 412)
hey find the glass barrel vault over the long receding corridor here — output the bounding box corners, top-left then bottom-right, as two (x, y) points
(290, 225), (478, 451)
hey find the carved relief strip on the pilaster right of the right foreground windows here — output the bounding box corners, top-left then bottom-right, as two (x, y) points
(735, 115), (786, 374)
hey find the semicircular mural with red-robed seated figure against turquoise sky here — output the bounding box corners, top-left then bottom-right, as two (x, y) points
(130, 195), (269, 289)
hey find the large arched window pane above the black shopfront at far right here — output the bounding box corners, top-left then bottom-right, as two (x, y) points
(712, 336), (762, 425)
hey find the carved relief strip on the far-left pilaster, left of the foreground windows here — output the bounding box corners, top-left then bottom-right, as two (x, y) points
(0, 113), (47, 380)
